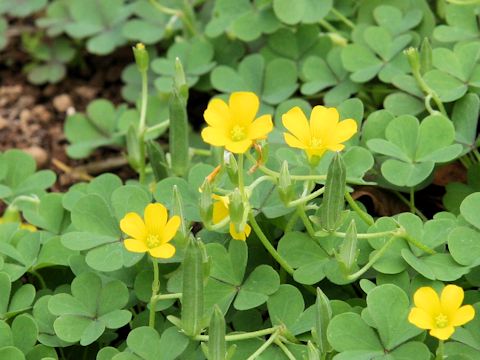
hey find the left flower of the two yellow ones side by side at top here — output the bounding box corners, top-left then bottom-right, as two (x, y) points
(202, 92), (273, 154)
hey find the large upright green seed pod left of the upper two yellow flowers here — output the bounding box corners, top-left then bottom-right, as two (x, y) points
(168, 88), (190, 176)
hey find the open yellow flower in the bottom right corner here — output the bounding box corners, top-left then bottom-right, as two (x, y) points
(408, 285), (475, 340)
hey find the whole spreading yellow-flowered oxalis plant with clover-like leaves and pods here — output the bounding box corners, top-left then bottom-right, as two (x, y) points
(0, 0), (480, 360)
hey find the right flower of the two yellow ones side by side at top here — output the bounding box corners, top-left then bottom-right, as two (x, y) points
(282, 105), (357, 158)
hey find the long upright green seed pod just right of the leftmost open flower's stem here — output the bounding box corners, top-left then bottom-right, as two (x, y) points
(182, 237), (204, 336)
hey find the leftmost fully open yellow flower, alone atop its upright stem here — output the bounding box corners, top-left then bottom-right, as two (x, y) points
(120, 203), (180, 259)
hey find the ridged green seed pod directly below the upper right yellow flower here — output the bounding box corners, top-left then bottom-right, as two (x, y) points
(318, 153), (347, 231)
